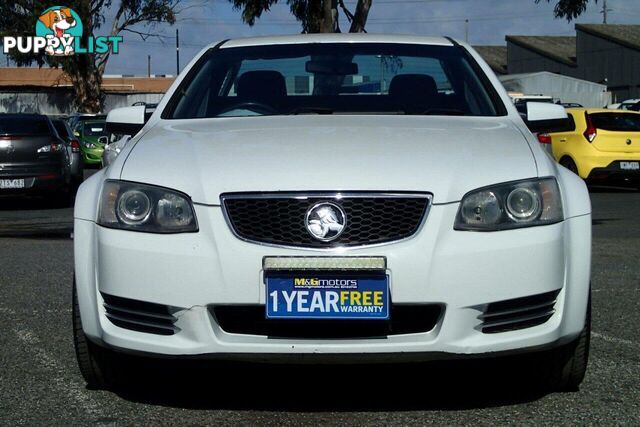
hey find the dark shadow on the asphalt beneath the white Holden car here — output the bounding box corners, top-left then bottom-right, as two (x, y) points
(116, 360), (547, 412)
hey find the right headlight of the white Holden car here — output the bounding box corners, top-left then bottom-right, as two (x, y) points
(454, 178), (563, 231)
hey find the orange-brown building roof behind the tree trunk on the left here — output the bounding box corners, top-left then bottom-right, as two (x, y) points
(0, 67), (174, 93)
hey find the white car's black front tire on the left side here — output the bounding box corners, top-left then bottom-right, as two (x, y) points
(72, 278), (119, 389)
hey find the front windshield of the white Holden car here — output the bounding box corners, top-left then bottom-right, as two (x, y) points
(163, 43), (504, 119)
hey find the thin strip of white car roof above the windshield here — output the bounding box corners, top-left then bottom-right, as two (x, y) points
(218, 33), (453, 49)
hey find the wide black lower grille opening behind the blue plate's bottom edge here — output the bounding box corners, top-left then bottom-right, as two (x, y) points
(209, 304), (444, 339)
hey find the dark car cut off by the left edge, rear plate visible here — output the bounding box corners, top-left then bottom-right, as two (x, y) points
(0, 114), (70, 200)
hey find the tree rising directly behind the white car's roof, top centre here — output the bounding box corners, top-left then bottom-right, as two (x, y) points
(229, 0), (373, 33)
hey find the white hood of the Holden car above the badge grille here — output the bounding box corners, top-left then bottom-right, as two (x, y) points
(120, 115), (537, 205)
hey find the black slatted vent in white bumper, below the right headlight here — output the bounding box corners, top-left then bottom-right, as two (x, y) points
(479, 290), (560, 334)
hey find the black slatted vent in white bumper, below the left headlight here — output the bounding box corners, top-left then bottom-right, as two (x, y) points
(102, 293), (178, 335)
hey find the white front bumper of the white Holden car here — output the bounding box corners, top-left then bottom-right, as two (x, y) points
(75, 204), (591, 360)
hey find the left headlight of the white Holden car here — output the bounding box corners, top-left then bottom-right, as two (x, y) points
(98, 181), (198, 233)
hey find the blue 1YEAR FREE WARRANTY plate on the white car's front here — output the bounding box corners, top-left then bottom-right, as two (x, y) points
(266, 274), (389, 320)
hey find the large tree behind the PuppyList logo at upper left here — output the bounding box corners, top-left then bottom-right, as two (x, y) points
(0, 0), (180, 113)
